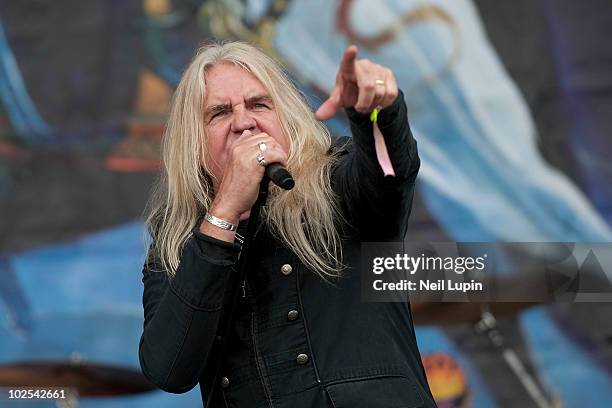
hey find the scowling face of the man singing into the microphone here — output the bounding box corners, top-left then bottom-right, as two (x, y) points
(204, 63), (289, 188)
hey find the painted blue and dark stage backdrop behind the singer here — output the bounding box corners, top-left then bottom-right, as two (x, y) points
(0, 0), (612, 408)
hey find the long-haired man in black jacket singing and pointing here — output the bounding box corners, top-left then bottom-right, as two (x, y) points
(139, 43), (435, 408)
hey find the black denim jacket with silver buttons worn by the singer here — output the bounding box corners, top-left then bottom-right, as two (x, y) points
(139, 92), (435, 408)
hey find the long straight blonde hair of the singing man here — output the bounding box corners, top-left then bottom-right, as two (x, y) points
(147, 42), (342, 278)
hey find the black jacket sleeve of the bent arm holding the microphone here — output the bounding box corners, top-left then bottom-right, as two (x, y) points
(139, 229), (239, 393)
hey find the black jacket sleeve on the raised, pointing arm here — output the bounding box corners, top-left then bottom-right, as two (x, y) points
(332, 90), (420, 241)
